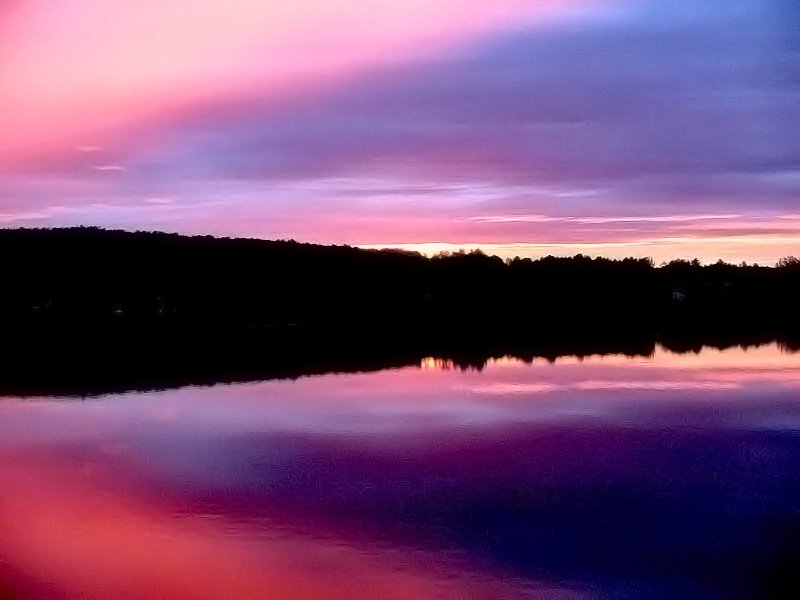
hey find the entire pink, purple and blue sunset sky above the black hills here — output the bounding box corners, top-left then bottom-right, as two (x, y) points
(0, 0), (800, 264)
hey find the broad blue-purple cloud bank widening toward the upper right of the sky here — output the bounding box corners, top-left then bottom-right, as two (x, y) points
(128, 0), (800, 207)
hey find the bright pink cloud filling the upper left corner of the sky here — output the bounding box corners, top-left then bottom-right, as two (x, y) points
(0, 0), (597, 164)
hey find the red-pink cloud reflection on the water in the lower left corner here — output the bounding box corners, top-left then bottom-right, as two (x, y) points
(0, 455), (568, 600)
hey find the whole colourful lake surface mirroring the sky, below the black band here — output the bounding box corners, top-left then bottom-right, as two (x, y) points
(0, 346), (800, 600)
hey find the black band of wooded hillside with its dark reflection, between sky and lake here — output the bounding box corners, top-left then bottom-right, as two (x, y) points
(0, 227), (800, 394)
